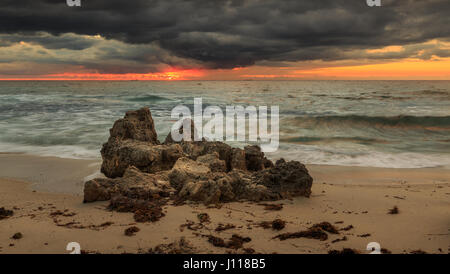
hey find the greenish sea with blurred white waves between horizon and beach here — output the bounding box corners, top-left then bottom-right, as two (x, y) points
(0, 81), (450, 168)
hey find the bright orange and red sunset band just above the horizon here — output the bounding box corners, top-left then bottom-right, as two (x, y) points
(0, 58), (450, 81)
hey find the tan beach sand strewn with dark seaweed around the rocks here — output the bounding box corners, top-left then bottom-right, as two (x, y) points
(0, 154), (450, 253)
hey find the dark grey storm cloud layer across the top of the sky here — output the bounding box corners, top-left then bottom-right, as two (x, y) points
(0, 0), (450, 70)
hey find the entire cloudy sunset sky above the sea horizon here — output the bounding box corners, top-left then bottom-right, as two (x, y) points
(0, 0), (450, 80)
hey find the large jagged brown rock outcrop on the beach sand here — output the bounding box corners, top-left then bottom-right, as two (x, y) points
(84, 108), (313, 220)
